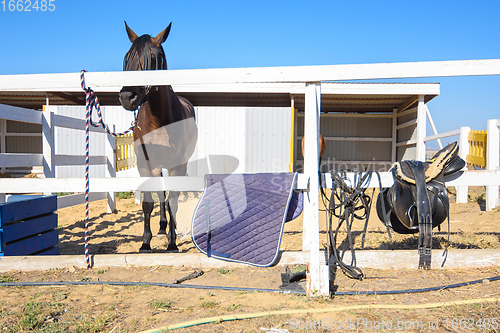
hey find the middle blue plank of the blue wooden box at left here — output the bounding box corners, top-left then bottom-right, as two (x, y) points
(2, 213), (57, 243)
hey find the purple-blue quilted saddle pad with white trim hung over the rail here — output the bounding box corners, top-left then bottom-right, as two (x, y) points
(191, 173), (302, 267)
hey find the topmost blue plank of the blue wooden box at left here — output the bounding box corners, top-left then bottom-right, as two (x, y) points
(0, 191), (57, 227)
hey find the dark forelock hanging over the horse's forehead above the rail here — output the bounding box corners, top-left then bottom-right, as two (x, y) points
(123, 35), (167, 71)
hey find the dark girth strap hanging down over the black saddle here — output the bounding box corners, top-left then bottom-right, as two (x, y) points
(404, 161), (432, 269)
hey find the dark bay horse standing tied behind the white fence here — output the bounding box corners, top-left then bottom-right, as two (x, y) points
(119, 22), (198, 252)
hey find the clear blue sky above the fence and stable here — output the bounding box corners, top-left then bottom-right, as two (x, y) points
(0, 0), (500, 145)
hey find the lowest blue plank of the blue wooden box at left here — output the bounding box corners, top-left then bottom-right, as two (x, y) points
(2, 230), (59, 256)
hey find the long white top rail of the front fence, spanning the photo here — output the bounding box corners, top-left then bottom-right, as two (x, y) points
(0, 59), (500, 92)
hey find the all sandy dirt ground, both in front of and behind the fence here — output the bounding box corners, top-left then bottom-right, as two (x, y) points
(0, 188), (500, 332)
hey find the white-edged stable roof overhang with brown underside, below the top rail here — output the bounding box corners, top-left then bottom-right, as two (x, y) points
(0, 82), (440, 113)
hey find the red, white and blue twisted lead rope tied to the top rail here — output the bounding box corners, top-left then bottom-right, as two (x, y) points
(80, 70), (137, 269)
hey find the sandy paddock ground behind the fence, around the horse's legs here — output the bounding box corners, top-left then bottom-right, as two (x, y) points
(57, 188), (500, 254)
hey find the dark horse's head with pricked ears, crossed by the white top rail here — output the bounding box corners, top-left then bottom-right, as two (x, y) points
(119, 22), (172, 111)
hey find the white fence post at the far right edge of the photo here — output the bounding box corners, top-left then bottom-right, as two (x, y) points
(486, 119), (500, 211)
